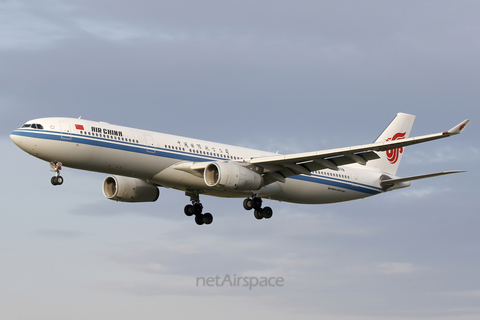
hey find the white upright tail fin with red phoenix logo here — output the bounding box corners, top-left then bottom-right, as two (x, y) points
(367, 113), (415, 175)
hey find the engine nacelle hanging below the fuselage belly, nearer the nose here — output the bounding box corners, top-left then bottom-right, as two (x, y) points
(103, 176), (160, 202)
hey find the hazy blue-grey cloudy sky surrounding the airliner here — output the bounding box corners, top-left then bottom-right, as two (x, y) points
(0, 0), (480, 320)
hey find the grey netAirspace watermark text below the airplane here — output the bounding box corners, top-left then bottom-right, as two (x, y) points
(197, 274), (285, 290)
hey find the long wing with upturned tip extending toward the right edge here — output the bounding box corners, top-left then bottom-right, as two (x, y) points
(247, 119), (470, 184)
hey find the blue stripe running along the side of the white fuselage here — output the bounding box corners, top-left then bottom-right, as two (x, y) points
(11, 129), (383, 195)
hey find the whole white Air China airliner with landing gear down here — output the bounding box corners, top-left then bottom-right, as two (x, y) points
(10, 113), (470, 225)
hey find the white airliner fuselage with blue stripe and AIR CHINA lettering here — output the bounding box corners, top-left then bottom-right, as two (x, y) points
(10, 118), (385, 204)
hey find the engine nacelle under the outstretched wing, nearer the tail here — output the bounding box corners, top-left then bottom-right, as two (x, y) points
(204, 162), (263, 190)
